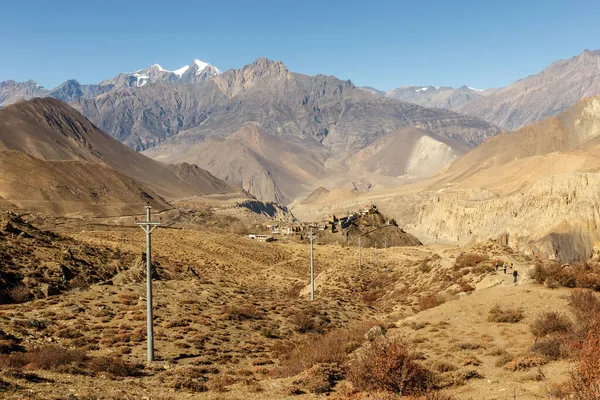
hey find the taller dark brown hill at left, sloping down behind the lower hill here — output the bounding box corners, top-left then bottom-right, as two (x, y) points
(0, 98), (235, 203)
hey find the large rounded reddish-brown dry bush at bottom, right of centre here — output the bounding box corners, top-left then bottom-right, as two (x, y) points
(348, 338), (434, 395)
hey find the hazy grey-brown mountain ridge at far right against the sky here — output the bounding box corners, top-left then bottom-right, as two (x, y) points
(362, 50), (600, 130)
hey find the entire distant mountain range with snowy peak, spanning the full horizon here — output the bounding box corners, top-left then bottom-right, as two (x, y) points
(0, 51), (600, 203)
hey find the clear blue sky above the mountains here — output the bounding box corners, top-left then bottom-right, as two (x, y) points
(0, 0), (600, 90)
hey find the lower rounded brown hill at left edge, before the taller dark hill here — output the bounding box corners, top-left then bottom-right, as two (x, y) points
(0, 150), (171, 216)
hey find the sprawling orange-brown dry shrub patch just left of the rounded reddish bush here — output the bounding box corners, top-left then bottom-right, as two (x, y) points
(275, 321), (377, 376)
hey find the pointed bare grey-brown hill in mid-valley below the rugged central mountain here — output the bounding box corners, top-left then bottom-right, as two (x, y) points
(146, 124), (332, 204)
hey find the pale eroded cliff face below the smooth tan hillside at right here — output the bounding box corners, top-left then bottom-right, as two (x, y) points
(408, 173), (600, 262)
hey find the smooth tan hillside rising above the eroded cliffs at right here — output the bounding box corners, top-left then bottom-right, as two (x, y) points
(429, 96), (600, 193)
